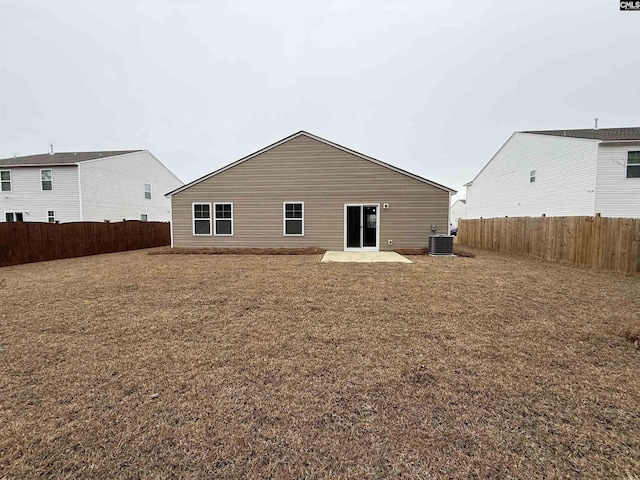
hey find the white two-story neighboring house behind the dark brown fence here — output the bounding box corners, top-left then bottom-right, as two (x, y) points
(0, 150), (183, 222)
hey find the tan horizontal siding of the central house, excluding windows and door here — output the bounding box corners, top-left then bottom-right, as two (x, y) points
(172, 135), (449, 250)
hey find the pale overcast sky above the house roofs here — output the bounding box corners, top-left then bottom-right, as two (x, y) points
(0, 0), (640, 198)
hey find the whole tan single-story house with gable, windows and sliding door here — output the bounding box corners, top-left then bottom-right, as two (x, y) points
(168, 132), (455, 250)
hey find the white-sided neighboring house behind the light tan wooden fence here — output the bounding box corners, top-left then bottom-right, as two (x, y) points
(465, 127), (640, 218)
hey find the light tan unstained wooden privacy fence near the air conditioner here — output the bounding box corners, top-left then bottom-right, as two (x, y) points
(457, 216), (640, 275)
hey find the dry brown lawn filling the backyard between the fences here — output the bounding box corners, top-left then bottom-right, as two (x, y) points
(0, 250), (640, 479)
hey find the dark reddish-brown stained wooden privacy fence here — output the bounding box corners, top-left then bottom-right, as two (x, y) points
(0, 221), (171, 267)
